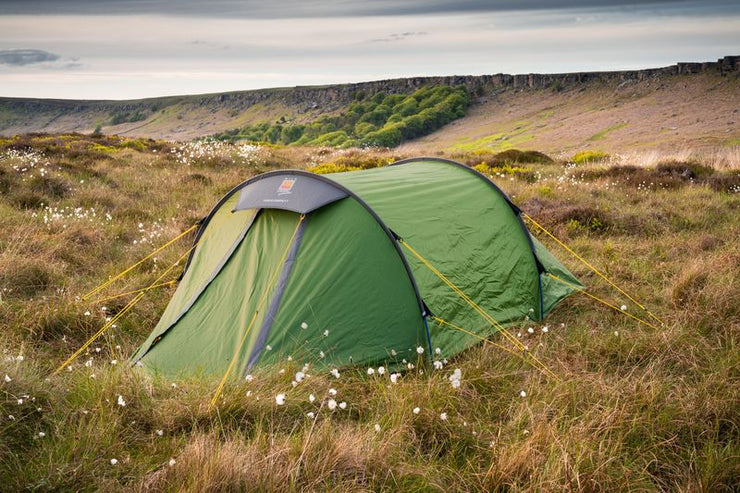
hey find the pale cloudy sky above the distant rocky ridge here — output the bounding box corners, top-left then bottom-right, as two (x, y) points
(0, 0), (740, 99)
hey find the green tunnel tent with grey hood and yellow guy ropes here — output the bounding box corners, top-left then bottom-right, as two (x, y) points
(134, 158), (580, 378)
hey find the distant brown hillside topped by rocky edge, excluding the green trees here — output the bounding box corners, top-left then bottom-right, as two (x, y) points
(0, 57), (740, 152)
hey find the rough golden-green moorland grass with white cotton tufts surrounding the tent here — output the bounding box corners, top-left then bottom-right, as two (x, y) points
(0, 135), (740, 492)
